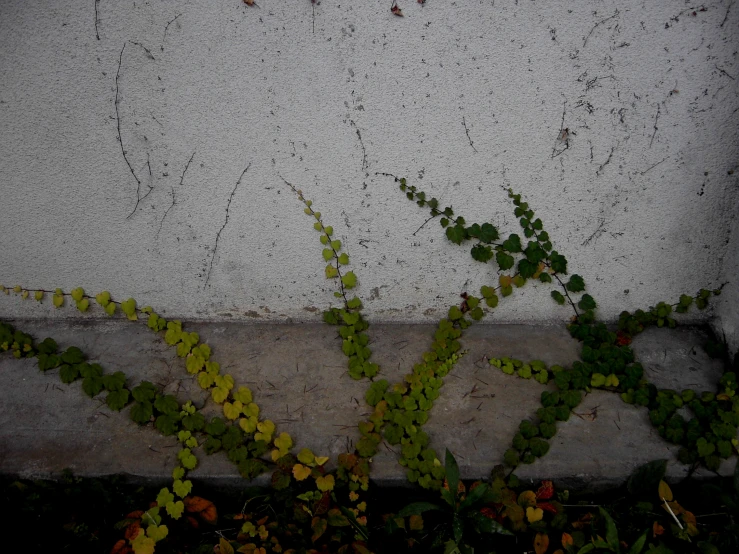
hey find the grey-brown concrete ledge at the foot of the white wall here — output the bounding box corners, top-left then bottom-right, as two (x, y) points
(0, 320), (735, 488)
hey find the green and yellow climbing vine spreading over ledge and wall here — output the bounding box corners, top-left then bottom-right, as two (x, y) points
(0, 170), (739, 553)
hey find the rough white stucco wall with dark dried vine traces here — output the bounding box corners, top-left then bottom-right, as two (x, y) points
(0, 0), (739, 325)
